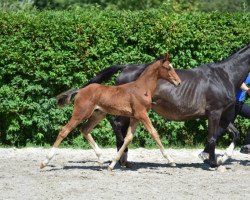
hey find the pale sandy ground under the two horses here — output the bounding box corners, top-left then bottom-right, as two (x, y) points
(0, 148), (250, 200)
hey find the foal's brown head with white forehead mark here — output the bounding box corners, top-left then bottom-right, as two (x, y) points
(159, 54), (181, 86)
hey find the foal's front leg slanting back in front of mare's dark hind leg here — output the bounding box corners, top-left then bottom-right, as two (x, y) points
(108, 119), (138, 170)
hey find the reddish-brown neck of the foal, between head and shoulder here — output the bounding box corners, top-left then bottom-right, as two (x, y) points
(135, 63), (158, 94)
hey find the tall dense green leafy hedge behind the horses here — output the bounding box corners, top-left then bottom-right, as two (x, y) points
(0, 8), (250, 146)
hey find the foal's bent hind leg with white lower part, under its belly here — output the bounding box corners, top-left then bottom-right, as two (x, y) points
(80, 110), (106, 164)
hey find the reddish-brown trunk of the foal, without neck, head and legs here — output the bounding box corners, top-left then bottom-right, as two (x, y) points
(75, 82), (147, 116)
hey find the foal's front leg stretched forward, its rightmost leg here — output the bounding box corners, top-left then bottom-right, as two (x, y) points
(140, 113), (176, 166)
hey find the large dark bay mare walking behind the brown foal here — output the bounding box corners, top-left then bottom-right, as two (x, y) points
(79, 44), (250, 167)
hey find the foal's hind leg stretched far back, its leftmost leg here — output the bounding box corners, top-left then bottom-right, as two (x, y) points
(40, 102), (94, 169)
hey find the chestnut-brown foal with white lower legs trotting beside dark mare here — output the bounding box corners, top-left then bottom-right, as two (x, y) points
(40, 54), (181, 170)
